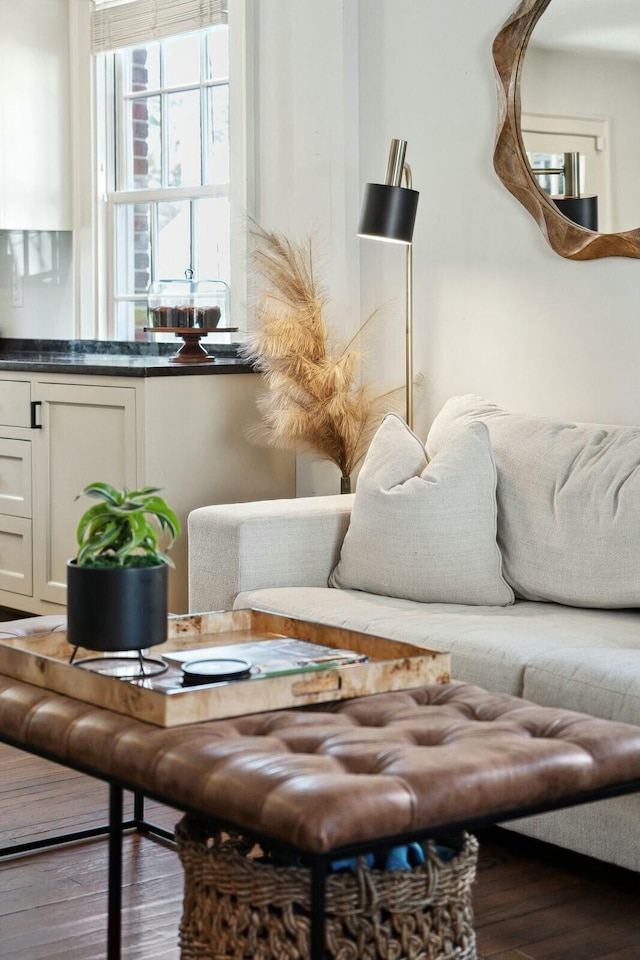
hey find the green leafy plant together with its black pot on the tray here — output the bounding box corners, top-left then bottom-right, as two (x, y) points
(67, 482), (180, 651)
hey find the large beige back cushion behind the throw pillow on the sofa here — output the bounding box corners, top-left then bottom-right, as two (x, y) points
(426, 395), (640, 607)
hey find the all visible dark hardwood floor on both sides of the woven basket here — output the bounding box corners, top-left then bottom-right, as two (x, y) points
(0, 745), (640, 960)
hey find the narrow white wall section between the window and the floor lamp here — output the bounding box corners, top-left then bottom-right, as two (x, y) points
(253, 0), (360, 494)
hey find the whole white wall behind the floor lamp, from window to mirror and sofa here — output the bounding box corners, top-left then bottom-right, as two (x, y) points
(257, 0), (640, 493)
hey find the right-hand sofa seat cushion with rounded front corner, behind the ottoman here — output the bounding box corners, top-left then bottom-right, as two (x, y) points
(524, 640), (640, 726)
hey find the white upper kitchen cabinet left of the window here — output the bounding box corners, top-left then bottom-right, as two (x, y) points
(0, 0), (73, 230)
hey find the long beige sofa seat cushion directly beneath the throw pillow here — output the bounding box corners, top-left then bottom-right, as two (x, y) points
(234, 587), (640, 696)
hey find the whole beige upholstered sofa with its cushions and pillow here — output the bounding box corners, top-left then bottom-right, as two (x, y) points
(189, 396), (640, 871)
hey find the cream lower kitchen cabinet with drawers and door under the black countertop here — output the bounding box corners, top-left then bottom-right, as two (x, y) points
(0, 371), (295, 614)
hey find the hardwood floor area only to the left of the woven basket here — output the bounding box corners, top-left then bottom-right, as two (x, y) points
(0, 745), (182, 960)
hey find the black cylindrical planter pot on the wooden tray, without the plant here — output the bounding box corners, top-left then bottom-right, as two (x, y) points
(67, 560), (168, 652)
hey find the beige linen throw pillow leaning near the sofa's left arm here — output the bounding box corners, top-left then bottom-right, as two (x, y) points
(329, 414), (514, 606)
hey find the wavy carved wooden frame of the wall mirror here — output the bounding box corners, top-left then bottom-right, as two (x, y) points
(493, 0), (640, 260)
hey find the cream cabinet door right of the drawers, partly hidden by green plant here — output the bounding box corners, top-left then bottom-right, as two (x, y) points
(33, 383), (137, 603)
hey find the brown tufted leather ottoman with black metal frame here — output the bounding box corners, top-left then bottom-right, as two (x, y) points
(0, 677), (640, 960)
